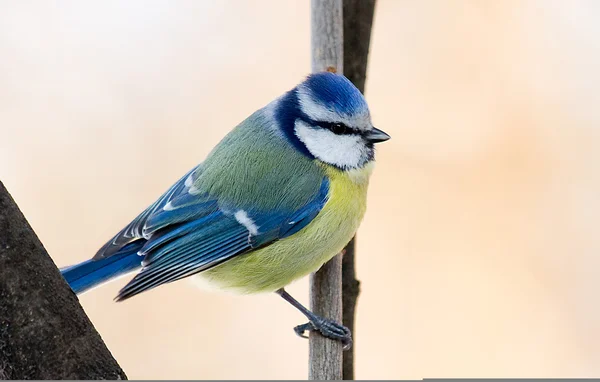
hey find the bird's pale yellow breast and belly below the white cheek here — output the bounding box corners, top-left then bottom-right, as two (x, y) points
(198, 162), (373, 293)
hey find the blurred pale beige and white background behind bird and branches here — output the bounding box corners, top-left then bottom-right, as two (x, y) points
(0, 0), (600, 379)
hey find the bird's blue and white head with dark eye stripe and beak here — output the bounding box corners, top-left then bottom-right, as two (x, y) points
(275, 72), (390, 170)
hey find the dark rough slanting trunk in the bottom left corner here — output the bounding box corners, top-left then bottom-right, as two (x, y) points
(0, 182), (127, 379)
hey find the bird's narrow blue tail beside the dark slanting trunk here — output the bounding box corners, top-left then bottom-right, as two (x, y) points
(60, 240), (145, 294)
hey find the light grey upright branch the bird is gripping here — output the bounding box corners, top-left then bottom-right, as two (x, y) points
(308, 0), (344, 380)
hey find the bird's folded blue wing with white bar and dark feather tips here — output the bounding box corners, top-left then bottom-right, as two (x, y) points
(112, 176), (329, 300)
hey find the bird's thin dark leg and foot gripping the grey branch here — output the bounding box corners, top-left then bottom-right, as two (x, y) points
(275, 288), (352, 350)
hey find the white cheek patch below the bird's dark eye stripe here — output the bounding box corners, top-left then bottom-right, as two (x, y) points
(295, 121), (368, 168)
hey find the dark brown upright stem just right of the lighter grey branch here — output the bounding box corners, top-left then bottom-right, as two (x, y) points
(342, 0), (375, 380)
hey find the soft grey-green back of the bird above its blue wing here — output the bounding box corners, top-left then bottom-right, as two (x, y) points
(195, 109), (325, 211)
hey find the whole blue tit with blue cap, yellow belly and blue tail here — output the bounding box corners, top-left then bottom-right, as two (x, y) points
(61, 72), (390, 346)
